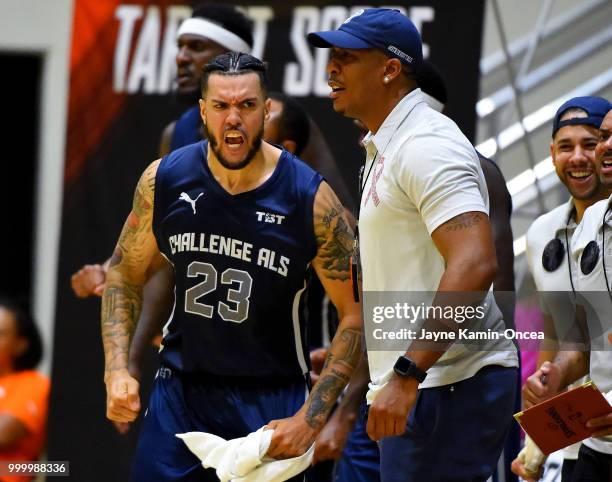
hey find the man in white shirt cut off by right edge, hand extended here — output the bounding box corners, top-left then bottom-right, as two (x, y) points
(524, 105), (612, 482)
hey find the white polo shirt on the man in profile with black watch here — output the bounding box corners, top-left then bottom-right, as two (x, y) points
(359, 89), (518, 398)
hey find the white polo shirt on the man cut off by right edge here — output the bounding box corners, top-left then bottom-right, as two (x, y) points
(571, 196), (612, 454)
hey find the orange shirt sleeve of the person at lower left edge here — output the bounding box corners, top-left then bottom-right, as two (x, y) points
(0, 372), (49, 433)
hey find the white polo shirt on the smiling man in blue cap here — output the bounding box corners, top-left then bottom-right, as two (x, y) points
(525, 198), (585, 460)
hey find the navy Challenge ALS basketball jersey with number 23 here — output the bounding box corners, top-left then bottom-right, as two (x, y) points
(153, 141), (322, 377)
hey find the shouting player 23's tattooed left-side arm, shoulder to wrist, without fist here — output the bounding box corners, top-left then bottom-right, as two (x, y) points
(102, 161), (159, 374)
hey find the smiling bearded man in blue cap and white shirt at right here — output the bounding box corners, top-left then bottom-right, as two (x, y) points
(516, 97), (610, 482)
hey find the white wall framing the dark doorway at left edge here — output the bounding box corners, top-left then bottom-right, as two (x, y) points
(0, 0), (73, 373)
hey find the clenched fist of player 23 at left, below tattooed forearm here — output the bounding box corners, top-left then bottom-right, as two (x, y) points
(104, 369), (140, 422)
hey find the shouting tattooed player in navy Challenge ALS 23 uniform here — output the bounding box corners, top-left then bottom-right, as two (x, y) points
(102, 52), (361, 482)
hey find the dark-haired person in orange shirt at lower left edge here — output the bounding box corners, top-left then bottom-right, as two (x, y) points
(0, 299), (49, 482)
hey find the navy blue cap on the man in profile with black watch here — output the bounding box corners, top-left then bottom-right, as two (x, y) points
(308, 8), (423, 67)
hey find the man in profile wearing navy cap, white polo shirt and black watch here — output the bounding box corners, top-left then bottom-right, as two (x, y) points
(308, 8), (518, 482)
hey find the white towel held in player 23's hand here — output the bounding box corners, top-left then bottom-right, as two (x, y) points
(176, 427), (314, 482)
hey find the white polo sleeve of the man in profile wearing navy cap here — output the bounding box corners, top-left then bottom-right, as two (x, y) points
(395, 135), (488, 234)
